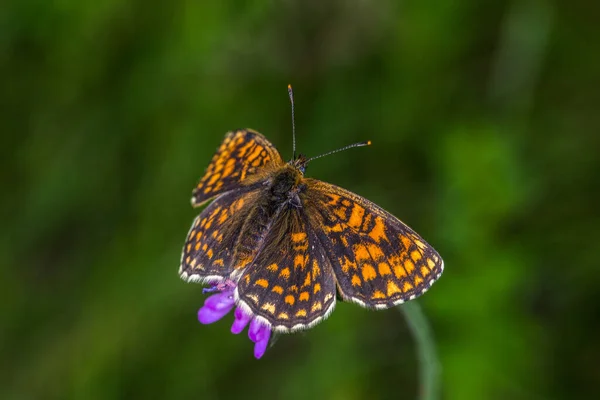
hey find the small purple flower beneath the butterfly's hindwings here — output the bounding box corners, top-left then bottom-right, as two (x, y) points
(198, 281), (271, 358)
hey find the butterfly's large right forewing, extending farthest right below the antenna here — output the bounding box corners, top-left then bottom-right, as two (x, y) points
(302, 179), (444, 309)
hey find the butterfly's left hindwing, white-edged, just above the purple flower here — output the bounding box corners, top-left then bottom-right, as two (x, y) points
(179, 187), (261, 283)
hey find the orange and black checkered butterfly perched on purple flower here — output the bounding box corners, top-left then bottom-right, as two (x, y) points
(179, 87), (444, 332)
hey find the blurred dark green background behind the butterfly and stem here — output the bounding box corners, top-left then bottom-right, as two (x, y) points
(0, 0), (600, 400)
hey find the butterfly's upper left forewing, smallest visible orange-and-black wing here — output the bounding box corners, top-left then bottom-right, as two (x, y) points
(192, 129), (284, 207)
